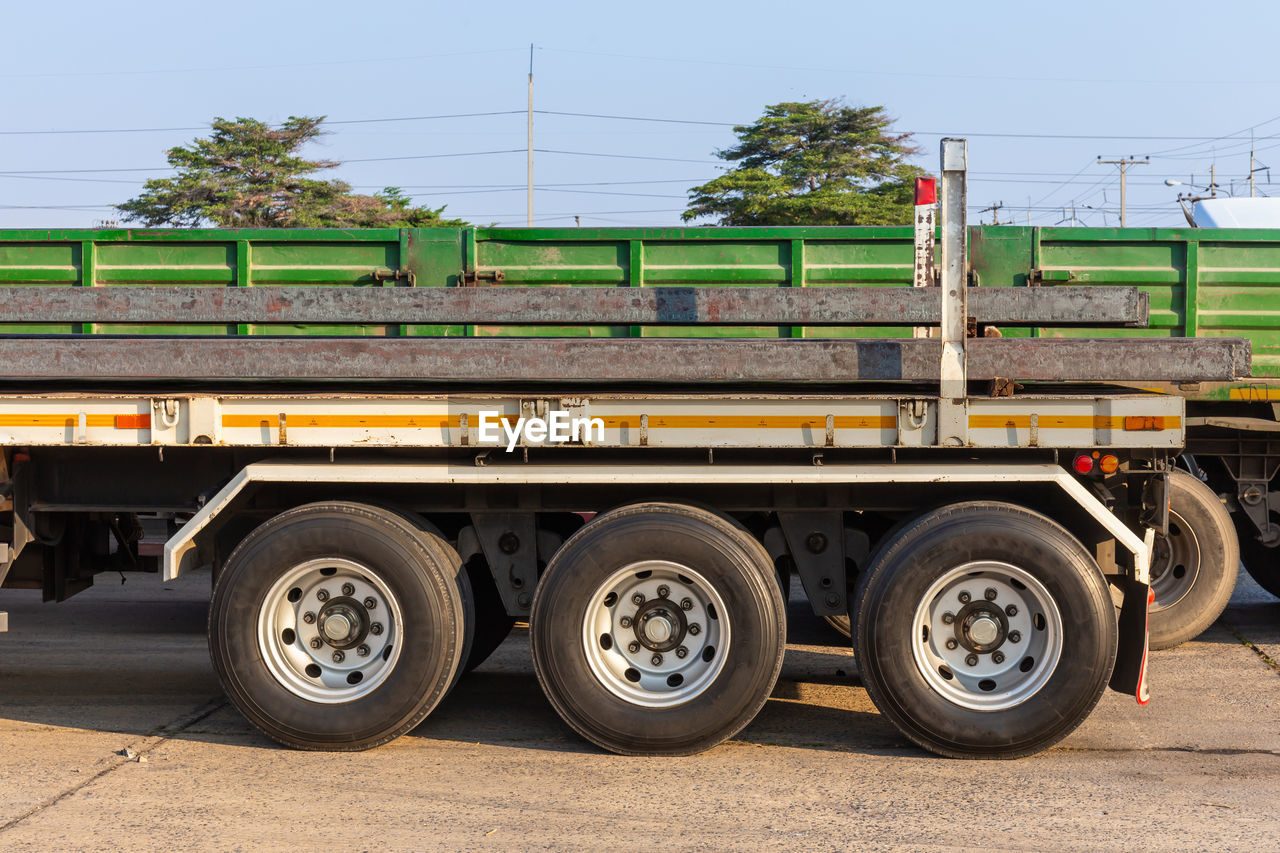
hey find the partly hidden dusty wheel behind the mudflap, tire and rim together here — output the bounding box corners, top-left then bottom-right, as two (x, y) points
(1149, 469), (1240, 649)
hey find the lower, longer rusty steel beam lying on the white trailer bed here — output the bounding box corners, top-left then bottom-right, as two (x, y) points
(0, 337), (1249, 381)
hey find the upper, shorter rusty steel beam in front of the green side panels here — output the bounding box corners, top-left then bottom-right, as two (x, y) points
(0, 286), (1148, 329)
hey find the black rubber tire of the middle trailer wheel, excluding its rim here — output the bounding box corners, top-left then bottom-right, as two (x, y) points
(530, 502), (786, 756)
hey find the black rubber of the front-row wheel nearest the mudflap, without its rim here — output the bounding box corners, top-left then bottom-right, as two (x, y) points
(854, 501), (1117, 758)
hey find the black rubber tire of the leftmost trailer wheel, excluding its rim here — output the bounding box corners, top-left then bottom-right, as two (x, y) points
(209, 502), (465, 752)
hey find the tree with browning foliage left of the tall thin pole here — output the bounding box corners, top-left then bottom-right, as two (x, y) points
(116, 117), (466, 228)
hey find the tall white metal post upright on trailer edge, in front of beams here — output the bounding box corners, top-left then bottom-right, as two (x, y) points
(938, 138), (969, 447)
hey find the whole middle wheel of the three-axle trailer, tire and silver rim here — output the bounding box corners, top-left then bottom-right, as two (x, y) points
(530, 503), (786, 756)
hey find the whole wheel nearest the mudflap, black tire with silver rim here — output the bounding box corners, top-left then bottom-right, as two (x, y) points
(854, 501), (1117, 758)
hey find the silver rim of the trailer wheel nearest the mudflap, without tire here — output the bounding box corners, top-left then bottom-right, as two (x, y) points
(911, 561), (1062, 711)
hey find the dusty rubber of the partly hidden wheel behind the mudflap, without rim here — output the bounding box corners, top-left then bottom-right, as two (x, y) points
(1148, 469), (1240, 649)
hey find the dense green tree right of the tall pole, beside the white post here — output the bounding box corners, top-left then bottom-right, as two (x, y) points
(681, 100), (924, 225)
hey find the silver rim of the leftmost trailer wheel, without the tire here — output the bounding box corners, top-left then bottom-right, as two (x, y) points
(257, 557), (403, 704)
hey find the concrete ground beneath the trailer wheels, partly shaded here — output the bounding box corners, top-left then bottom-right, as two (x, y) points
(0, 563), (1280, 850)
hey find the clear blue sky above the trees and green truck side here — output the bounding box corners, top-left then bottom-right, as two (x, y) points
(0, 0), (1280, 228)
